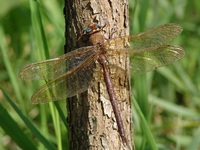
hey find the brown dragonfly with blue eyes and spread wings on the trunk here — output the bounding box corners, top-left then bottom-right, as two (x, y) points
(19, 23), (185, 144)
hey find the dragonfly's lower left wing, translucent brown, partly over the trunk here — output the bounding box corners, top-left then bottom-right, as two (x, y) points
(31, 55), (97, 104)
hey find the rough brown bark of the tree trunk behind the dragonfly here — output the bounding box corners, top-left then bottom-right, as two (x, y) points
(64, 0), (133, 150)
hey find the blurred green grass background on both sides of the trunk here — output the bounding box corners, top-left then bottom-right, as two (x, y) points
(0, 0), (200, 150)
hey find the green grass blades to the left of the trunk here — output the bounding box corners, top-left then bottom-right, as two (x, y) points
(0, 0), (67, 150)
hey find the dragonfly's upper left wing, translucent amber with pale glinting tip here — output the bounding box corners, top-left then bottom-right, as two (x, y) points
(19, 46), (94, 80)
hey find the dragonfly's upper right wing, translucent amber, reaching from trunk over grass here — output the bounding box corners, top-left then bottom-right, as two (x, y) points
(104, 23), (182, 50)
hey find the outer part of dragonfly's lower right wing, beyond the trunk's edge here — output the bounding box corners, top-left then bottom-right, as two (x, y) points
(130, 45), (185, 74)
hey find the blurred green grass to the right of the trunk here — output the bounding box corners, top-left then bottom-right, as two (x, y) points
(130, 0), (200, 150)
